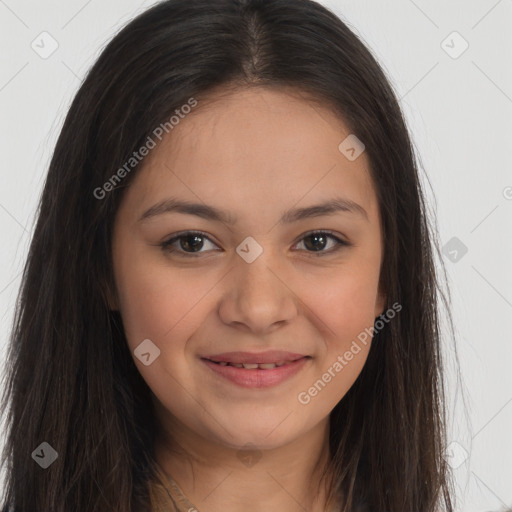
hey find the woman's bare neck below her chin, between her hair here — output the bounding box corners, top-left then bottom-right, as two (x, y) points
(155, 417), (338, 512)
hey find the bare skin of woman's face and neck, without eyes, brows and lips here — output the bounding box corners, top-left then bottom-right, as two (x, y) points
(111, 88), (385, 512)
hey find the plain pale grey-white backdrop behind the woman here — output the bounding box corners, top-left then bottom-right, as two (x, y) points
(0, 0), (512, 512)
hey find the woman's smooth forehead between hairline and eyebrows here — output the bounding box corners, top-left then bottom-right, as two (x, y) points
(118, 88), (377, 226)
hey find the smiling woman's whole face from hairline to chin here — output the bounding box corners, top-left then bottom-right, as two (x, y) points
(112, 88), (385, 448)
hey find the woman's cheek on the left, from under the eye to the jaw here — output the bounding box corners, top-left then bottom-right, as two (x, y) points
(113, 260), (211, 410)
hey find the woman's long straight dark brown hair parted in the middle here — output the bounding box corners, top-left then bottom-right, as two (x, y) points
(2, 0), (453, 512)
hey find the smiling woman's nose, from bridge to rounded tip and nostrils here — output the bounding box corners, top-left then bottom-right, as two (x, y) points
(219, 251), (299, 335)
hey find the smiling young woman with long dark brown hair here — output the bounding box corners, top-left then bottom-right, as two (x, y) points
(3, 0), (453, 512)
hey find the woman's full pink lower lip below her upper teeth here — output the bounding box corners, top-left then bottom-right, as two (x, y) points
(202, 357), (310, 388)
